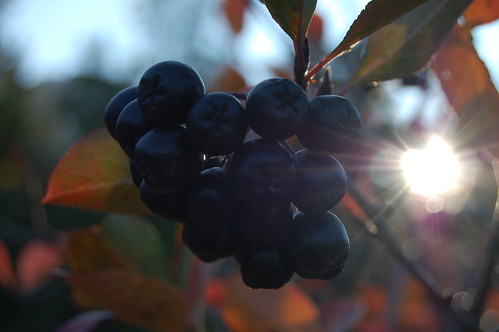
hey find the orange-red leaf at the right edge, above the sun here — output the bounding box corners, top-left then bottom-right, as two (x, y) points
(432, 26), (499, 156)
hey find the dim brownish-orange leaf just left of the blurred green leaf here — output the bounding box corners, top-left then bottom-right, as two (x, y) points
(67, 228), (129, 273)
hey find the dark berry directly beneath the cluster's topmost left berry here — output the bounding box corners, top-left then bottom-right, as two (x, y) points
(135, 126), (203, 192)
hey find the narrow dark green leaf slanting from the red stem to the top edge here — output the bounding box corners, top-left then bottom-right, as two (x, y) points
(307, 0), (428, 79)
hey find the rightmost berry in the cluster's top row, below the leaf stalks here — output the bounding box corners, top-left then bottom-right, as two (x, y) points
(297, 95), (362, 154)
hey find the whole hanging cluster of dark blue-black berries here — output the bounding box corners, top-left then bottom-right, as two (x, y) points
(105, 61), (361, 288)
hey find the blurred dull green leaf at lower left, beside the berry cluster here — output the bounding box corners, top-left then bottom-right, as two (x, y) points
(100, 215), (171, 279)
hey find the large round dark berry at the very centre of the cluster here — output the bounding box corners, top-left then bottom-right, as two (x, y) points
(227, 138), (295, 208)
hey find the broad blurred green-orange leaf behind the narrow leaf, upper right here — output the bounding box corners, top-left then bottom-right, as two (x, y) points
(345, 0), (472, 87)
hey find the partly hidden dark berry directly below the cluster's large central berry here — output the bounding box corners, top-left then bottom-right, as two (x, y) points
(236, 202), (293, 245)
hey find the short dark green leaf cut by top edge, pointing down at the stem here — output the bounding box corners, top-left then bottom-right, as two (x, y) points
(263, 0), (317, 42)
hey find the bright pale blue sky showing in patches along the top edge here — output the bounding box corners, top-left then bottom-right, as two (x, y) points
(0, 0), (499, 86)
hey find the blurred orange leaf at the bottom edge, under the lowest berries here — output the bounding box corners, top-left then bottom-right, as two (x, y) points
(208, 273), (319, 332)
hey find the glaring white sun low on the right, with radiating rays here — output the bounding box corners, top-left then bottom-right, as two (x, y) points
(401, 136), (462, 197)
